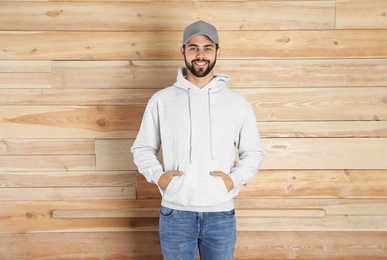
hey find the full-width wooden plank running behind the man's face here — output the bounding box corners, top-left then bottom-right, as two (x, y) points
(0, 30), (387, 60)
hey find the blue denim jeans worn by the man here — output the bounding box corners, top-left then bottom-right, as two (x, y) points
(159, 206), (236, 260)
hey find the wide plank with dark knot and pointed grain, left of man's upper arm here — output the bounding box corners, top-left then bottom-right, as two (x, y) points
(0, 106), (144, 138)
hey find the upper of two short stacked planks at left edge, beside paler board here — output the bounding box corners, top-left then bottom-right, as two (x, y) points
(0, 139), (95, 155)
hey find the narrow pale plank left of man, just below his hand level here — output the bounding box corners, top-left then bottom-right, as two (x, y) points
(0, 187), (136, 201)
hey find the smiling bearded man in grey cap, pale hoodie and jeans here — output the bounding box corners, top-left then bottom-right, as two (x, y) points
(131, 21), (265, 260)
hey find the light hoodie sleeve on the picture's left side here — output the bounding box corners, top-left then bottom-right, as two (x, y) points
(131, 98), (164, 185)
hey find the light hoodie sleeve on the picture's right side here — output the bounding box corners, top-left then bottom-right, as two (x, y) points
(230, 101), (266, 188)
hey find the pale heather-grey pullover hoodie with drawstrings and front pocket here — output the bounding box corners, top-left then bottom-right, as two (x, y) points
(131, 68), (265, 212)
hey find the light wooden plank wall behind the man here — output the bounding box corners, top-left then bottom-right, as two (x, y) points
(0, 0), (387, 260)
